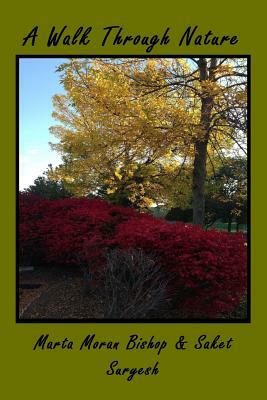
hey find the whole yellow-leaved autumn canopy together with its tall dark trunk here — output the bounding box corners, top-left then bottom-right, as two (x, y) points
(51, 58), (246, 224)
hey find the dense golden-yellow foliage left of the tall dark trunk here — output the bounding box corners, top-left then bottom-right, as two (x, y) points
(51, 60), (193, 208)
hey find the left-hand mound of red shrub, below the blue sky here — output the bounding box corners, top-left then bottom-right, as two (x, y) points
(19, 194), (136, 265)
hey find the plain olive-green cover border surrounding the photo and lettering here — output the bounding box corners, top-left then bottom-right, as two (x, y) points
(0, 0), (266, 399)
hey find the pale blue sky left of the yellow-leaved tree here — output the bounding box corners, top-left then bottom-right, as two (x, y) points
(19, 58), (66, 190)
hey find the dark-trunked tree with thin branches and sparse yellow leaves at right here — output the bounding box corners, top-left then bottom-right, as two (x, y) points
(115, 57), (247, 225)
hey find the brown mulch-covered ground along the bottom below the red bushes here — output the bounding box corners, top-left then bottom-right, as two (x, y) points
(19, 267), (246, 320)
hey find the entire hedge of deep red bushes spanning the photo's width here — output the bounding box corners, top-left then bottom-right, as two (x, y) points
(19, 194), (247, 316)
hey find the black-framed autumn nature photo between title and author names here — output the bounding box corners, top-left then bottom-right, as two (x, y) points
(16, 55), (250, 323)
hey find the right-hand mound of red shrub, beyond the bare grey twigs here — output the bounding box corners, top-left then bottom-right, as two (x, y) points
(115, 218), (247, 315)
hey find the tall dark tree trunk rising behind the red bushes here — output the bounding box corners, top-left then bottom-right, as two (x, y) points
(192, 58), (217, 226)
